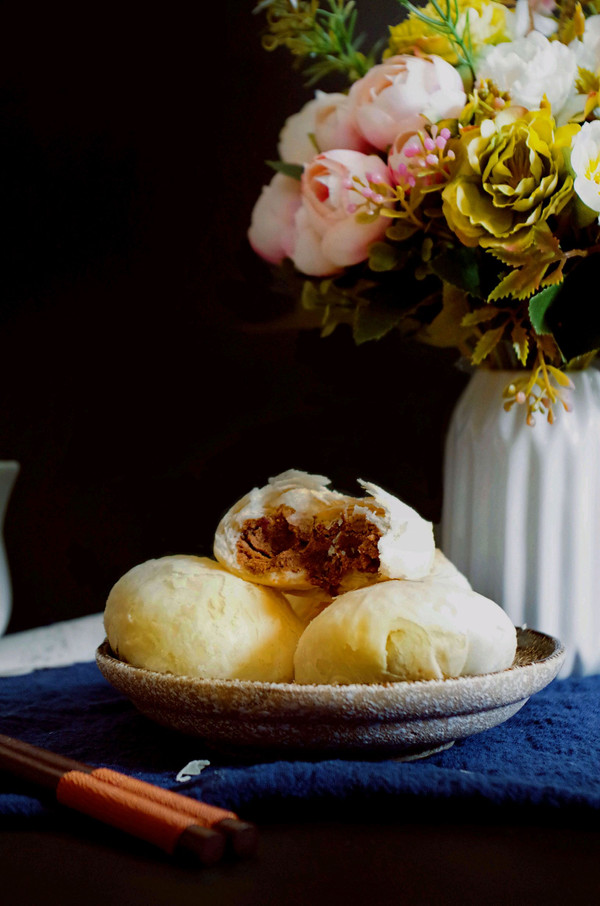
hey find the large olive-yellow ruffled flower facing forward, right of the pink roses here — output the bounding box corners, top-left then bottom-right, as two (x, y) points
(442, 106), (580, 247)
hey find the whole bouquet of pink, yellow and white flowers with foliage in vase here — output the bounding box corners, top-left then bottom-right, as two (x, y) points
(249, 0), (600, 424)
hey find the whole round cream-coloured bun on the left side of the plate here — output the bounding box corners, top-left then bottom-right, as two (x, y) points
(104, 555), (303, 682)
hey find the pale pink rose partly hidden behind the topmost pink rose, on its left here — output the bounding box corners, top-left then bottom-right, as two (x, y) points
(278, 91), (371, 164)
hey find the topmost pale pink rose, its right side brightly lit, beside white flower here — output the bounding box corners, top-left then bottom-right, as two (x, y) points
(349, 54), (467, 151)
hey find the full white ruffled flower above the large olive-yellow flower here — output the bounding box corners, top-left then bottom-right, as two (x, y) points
(477, 31), (577, 123)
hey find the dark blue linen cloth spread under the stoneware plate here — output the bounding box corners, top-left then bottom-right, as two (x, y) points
(0, 663), (600, 824)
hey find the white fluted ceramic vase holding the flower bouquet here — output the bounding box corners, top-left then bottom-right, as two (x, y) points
(441, 368), (600, 676)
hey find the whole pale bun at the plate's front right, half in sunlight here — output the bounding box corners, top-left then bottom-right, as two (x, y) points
(294, 579), (516, 684)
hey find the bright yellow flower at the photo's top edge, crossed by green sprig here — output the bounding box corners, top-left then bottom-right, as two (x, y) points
(384, 0), (510, 65)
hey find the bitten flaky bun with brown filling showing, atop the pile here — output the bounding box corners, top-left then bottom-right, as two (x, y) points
(214, 470), (435, 596)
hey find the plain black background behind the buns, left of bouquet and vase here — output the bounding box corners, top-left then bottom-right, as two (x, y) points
(0, 0), (466, 631)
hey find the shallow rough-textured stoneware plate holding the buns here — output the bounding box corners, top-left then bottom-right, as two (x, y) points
(96, 629), (565, 759)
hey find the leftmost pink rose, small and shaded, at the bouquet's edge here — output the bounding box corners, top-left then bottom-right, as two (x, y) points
(248, 173), (302, 264)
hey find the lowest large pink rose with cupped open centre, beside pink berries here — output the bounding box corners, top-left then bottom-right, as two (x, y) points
(292, 150), (390, 277)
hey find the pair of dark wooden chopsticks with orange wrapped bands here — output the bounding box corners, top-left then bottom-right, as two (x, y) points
(0, 734), (257, 865)
